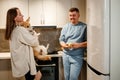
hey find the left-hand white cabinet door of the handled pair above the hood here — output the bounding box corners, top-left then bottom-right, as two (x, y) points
(29, 0), (43, 26)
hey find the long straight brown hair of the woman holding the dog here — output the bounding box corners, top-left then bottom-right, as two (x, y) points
(5, 7), (18, 40)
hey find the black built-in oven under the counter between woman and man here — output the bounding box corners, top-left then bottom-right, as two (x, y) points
(36, 57), (59, 80)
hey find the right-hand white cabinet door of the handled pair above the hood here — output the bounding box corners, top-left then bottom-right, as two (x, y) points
(43, 0), (57, 25)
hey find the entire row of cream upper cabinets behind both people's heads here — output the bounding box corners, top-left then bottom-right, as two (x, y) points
(0, 0), (86, 28)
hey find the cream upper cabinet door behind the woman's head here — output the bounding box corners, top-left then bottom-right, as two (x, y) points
(0, 0), (28, 28)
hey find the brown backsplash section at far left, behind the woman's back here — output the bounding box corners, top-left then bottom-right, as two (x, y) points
(0, 29), (10, 52)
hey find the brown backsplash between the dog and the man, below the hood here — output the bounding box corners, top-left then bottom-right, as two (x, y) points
(34, 27), (61, 53)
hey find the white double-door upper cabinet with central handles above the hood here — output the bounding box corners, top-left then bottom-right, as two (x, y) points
(29, 0), (56, 26)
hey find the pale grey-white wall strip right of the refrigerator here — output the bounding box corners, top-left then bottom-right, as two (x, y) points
(110, 0), (120, 80)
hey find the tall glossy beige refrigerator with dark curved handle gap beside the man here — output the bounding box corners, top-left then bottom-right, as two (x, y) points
(87, 0), (110, 80)
